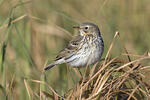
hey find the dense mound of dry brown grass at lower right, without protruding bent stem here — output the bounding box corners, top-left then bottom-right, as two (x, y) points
(66, 57), (150, 100)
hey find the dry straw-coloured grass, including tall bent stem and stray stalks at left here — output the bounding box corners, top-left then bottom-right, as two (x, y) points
(25, 32), (150, 100)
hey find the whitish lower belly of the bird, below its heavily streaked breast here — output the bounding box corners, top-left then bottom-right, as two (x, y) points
(68, 44), (101, 67)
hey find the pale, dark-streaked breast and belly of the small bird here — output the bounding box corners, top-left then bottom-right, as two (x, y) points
(68, 38), (103, 67)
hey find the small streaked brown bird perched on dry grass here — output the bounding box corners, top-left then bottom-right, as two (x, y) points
(44, 22), (104, 71)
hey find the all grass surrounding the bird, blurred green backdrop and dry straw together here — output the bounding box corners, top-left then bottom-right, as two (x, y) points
(0, 0), (150, 100)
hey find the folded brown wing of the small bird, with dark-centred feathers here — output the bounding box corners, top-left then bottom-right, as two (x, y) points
(56, 35), (83, 60)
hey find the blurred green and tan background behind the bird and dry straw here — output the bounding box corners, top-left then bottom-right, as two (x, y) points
(0, 0), (150, 100)
